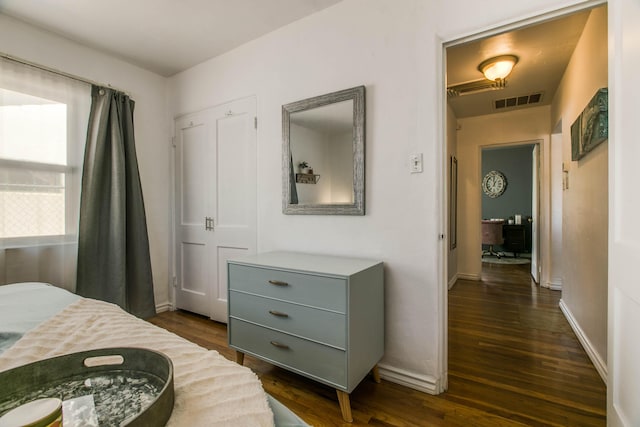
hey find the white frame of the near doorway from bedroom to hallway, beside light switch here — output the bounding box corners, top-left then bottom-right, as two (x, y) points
(436, 0), (612, 393)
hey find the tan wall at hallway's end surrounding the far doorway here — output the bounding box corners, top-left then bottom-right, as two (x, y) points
(457, 106), (550, 281)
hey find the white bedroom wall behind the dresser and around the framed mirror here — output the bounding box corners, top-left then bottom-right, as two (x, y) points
(170, 0), (441, 389)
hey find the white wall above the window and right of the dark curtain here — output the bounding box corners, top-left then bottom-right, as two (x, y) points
(0, 14), (170, 306)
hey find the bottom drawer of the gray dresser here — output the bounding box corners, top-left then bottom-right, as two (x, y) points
(229, 318), (347, 388)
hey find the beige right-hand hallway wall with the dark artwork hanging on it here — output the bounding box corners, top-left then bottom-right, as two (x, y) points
(552, 8), (609, 369)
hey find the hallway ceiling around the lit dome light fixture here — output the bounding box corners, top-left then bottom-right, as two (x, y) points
(447, 11), (590, 118)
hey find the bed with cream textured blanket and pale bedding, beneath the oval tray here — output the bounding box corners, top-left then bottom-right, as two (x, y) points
(0, 283), (307, 427)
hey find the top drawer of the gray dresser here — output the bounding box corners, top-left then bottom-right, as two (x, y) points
(229, 264), (347, 313)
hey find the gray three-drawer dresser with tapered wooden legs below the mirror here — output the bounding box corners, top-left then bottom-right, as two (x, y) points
(227, 252), (384, 422)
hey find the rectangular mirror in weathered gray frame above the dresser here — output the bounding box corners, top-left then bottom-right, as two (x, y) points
(282, 86), (365, 215)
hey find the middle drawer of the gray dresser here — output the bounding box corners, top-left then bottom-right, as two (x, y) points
(229, 291), (346, 350)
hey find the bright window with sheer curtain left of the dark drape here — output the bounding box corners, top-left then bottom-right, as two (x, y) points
(0, 59), (91, 246)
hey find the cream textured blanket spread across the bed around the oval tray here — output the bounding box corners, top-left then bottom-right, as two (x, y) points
(0, 299), (273, 426)
